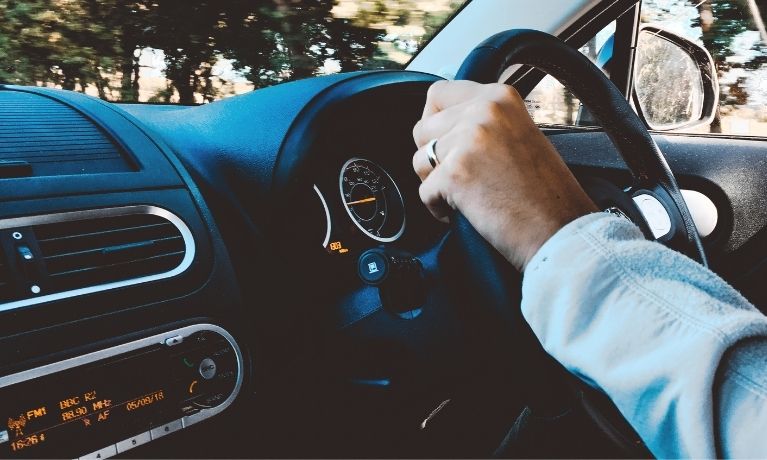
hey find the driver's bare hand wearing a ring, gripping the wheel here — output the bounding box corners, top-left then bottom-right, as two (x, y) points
(413, 81), (597, 271)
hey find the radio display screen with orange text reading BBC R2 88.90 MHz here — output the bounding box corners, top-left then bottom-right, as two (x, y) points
(0, 346), (182, 458)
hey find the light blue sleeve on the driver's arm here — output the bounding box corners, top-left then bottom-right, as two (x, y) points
(522, 213), (767, 458)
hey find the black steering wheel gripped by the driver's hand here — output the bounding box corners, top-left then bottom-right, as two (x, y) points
(452, 29), (706, 454)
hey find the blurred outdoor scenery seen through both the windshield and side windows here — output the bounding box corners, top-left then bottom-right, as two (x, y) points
(0, 0), (767, 136)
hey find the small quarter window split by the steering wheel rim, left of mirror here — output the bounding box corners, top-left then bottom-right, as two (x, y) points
(525, 21), (616, 126)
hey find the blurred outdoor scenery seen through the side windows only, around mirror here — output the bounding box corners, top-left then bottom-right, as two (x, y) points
(528, 0), (767, 137)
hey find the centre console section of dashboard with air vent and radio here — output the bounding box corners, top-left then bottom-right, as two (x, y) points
(0, 87), (249, 458)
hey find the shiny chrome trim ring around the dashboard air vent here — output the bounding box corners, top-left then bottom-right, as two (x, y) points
(0, 205), (196, 312)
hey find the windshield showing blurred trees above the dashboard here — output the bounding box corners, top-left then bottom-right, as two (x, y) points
(0, 0), (467, 104)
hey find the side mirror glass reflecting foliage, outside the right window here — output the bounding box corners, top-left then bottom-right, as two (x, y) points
(634, 25), (719, 131)
